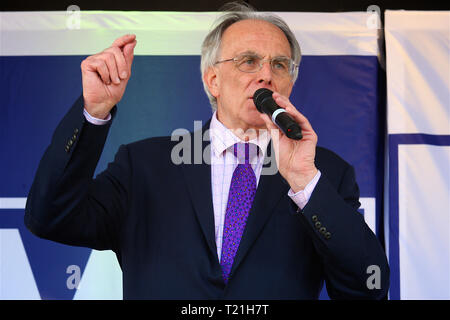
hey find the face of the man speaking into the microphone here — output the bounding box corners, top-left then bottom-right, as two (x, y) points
(210, 20), (293, 131)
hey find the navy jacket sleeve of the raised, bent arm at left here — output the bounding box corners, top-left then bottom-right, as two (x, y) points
(24, 97), (130, 250)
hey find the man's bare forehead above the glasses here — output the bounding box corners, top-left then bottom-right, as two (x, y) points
(221, 19), (291, 57)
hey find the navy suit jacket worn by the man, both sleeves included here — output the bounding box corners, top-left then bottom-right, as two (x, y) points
(24, 97), (389, 299)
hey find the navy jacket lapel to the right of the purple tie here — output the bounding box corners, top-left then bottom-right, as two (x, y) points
(231, 143), (289, 274)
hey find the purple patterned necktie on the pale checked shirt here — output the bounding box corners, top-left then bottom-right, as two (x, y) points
(220, 143), (259, 283)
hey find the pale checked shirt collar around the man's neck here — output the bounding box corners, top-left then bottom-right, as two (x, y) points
(209, 111), (270, 157)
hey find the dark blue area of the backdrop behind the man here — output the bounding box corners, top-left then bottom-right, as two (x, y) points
(0, 55), (385, 299)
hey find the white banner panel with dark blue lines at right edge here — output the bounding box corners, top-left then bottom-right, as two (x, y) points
(385, 11), (450, 299)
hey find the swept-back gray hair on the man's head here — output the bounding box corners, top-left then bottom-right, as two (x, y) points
(200, 2), (302, 110)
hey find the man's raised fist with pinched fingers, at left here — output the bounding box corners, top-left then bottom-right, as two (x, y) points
(81, 34), (137, 119)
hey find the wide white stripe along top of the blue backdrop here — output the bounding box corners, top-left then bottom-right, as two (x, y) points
(0, 8), (379, 56)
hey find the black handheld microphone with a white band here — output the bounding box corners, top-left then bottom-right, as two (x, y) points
(253, 88), (303, 140)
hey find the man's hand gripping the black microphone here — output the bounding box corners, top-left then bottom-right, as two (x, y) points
(260, 92), (317, 192)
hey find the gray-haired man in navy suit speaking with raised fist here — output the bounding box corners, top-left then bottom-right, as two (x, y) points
(25, 6), (389, 299)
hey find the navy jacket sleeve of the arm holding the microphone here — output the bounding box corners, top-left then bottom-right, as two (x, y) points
(301, 160), (389, 299)
